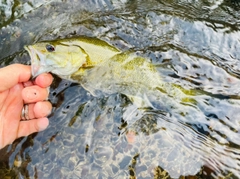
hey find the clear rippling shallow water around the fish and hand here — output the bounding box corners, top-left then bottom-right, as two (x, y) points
(0, 0), (240, 178)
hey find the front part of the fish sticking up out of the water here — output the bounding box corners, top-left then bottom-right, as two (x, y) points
(25, 37), (120, 80)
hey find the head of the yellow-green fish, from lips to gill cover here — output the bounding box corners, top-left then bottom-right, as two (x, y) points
(25, 41), (88, 79)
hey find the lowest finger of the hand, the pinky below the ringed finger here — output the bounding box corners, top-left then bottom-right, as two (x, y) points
(17, 117), (49, 137)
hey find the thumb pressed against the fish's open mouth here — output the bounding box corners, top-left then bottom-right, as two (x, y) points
(0, 64), (31, 92)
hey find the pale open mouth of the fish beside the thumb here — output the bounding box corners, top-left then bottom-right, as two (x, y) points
(24, 46), (43, 78)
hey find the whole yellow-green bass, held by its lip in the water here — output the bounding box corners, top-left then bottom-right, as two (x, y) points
(25, 36), (196, 107)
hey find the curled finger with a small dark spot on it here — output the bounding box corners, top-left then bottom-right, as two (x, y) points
(22, 85), (48, 103)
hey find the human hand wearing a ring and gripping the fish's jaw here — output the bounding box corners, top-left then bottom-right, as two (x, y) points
(0, 64), (53, 149)
